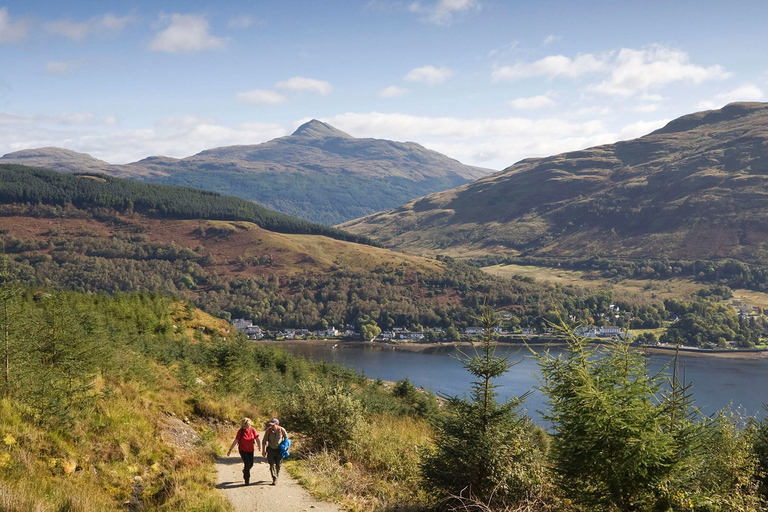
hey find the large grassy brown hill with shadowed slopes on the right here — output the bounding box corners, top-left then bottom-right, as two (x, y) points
(341, 103), (768, 264)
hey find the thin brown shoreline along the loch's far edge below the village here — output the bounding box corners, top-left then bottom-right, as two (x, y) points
(258, 339), (768, 360)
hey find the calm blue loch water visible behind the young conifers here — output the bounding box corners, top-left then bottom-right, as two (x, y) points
(281, 342), (768, 422)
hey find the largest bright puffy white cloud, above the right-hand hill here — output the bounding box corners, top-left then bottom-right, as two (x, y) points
(590, 45), (731, 97)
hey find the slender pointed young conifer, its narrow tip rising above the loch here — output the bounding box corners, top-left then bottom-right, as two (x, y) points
(422, 308), (542, 510)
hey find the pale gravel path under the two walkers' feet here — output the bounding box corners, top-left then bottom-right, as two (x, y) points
(216, 455), (341, 512)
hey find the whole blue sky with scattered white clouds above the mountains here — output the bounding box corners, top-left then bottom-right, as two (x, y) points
(0, 0), (768, 169)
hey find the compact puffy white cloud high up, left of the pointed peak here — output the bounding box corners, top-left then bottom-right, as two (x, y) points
(149, 14), (226, 53)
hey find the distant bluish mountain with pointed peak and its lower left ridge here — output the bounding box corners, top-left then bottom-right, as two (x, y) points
(0, 120), (491, 225)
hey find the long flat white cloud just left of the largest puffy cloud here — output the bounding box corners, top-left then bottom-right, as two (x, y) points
(492, 53), (610, 82)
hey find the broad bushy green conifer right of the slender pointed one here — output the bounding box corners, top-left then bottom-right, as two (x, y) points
(538, 318), (680, 512)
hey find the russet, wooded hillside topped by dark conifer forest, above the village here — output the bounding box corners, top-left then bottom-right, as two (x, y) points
(0, 162), (668, 329)
